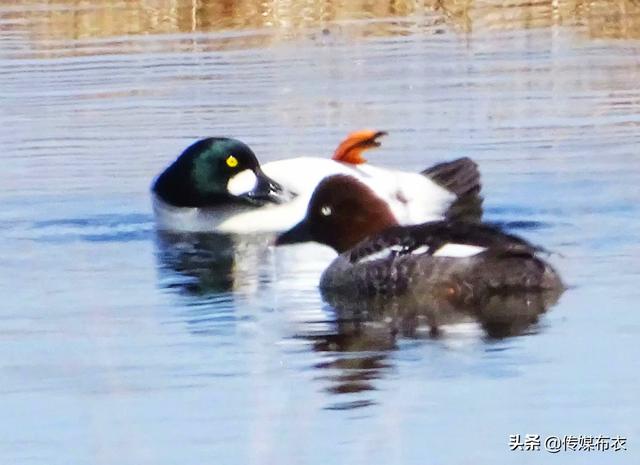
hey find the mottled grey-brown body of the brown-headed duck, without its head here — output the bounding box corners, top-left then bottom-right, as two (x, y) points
(320, 221), (563, 299)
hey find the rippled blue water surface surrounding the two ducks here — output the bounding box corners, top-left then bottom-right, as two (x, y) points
(0, 2), (640, 465)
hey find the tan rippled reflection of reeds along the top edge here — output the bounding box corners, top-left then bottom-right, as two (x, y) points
(0, 0), (640, 54)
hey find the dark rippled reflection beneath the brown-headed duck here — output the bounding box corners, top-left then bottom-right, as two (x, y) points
(307, 289), (562, 409)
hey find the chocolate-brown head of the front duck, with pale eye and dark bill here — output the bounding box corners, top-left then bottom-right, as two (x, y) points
(276, 175), (398, 253)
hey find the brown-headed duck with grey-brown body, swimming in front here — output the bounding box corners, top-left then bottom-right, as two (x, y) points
(275, 175), (563, 301)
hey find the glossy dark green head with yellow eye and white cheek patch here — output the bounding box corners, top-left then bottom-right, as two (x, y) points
(152, 137), (283, 207)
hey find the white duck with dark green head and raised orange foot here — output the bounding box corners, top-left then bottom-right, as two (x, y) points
(151, 130), (481, 234)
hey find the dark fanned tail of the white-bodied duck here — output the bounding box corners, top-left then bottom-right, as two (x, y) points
(422, 157), (482, 222)
